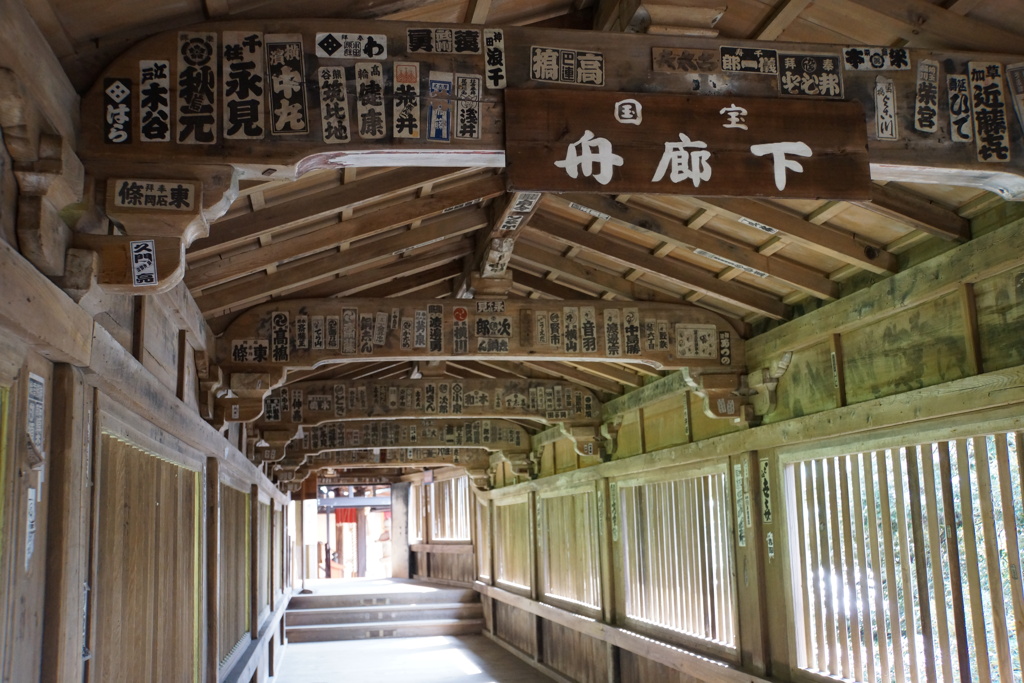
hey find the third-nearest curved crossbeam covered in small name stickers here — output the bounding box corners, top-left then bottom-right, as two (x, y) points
(255, 379), (601, 430)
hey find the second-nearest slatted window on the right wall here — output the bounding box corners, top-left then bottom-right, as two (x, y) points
(612, 466), (737, 653)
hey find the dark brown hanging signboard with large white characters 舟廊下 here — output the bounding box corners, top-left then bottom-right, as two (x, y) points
(505, 89), (870, 200)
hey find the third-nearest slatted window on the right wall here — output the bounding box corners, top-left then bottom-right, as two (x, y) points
(537, 485), (601, 612)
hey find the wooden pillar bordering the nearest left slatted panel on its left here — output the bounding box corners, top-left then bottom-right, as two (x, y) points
(39, 365), (93, 683)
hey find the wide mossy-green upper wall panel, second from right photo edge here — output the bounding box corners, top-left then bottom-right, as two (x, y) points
(828, 293), (969, 404)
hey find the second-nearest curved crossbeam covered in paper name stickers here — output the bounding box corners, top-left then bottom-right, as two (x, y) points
(217, 299), (744, 374)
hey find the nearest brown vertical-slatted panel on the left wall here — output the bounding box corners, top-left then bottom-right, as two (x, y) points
(87, 434), (200, 683)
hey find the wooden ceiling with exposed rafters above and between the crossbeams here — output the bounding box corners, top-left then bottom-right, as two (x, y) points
(26, 0), (1024, 481)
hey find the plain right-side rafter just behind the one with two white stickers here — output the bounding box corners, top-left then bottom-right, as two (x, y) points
(530, 215), (791, 319)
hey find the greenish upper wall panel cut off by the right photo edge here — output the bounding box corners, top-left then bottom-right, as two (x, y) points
(974, 268), (1024, 372)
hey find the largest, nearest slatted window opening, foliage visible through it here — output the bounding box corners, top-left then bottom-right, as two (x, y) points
(784, 431), (1024, 683)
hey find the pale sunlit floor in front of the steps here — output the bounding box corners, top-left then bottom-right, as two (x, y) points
(273, 636), (552, 683)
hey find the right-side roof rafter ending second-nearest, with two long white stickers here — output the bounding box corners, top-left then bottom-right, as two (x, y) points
(557, 194), (839, 299)
